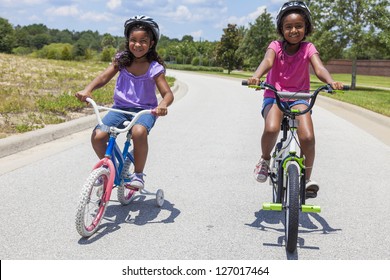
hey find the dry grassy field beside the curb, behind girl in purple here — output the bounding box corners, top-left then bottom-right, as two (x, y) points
(0, 53), (175, 138)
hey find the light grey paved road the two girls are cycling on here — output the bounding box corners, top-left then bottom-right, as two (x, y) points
(0, 71), (390, 260)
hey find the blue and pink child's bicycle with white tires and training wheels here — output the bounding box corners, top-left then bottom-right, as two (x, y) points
(76, 98), (164, 237)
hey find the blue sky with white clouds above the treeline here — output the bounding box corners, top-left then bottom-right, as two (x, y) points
(0, 0), (286, 41)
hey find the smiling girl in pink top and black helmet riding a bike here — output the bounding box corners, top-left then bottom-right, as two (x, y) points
(248, 1), (343, 198)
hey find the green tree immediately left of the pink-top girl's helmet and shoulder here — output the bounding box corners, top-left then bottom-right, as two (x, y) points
(238, 10), (278, 68)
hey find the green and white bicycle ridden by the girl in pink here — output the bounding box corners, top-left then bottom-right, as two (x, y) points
(242, 81), (348, 252)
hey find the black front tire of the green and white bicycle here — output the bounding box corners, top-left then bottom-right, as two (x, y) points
(285, 164), (299, 253)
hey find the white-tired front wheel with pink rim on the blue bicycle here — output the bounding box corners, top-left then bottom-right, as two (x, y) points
(76, 166), (112, 237)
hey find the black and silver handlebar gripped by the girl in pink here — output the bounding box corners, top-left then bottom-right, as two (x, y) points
(242, 80), (349, 116)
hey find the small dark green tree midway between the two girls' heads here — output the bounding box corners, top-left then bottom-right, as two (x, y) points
(217, 24), (242, 74)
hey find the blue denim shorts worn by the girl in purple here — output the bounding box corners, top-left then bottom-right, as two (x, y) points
(95, 108), (157, 134)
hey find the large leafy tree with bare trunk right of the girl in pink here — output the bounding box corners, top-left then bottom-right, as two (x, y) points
(309, 0), (390, 89)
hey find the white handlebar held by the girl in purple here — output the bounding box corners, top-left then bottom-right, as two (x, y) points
(86, 97), (156, 133)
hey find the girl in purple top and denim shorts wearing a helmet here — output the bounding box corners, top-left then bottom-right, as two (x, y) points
(75, 16), (173, 189)
